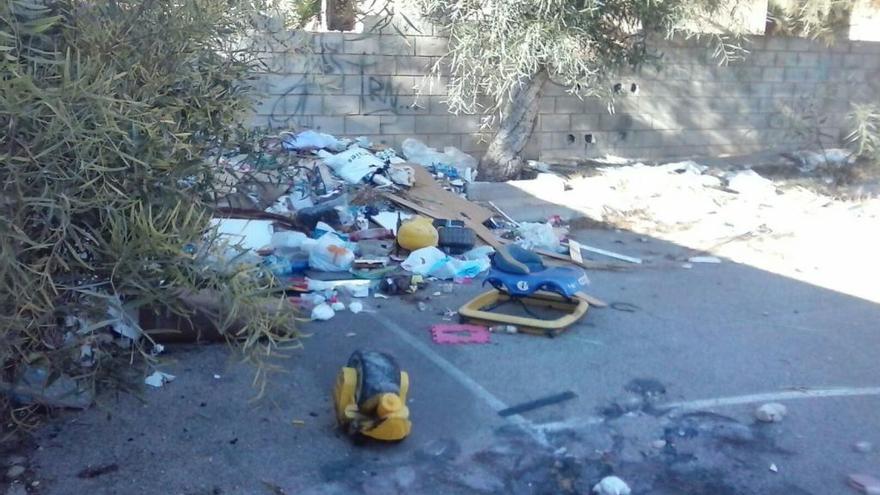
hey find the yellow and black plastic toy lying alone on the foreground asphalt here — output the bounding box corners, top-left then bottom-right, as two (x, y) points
(333, 351), (412, 441)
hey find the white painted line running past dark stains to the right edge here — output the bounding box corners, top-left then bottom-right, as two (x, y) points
(534, 387), (880, 433)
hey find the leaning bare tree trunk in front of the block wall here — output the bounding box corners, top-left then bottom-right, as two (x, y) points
(479, 70), (549, 181)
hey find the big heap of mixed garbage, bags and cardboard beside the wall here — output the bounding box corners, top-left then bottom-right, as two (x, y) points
(211, 130), (567, 321)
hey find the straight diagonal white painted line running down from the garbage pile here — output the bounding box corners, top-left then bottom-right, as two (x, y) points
(370, 314), (550, 446)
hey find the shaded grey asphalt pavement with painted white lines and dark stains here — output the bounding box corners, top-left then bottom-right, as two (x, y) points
(10, 230), (880, 495)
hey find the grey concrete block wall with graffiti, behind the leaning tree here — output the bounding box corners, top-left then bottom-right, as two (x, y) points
(253, 26), (880, 160)
